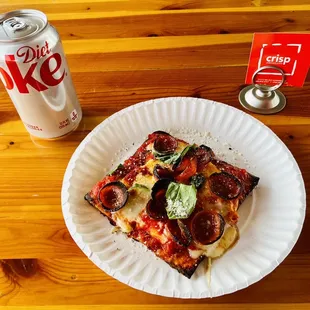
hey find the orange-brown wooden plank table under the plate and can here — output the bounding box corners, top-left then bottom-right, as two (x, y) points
(0, 0), (310, 310)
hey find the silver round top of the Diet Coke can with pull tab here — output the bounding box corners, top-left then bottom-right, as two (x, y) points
(0, 10), (47, 43)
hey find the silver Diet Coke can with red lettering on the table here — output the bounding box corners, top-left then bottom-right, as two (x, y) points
(0, 10), (82, 139)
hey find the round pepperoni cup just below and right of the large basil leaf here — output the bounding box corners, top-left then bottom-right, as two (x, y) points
(191, 211), (225, 245)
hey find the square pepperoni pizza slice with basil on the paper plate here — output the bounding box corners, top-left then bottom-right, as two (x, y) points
(85, 131), (259, 278)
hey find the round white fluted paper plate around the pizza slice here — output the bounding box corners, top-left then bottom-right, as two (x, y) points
(62, 97), (305, 298)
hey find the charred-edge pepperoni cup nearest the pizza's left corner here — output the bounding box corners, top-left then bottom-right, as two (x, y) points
(98, 182), (128, 212)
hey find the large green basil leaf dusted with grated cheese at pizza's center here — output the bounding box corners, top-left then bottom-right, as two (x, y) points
(166, 182), (197, 220)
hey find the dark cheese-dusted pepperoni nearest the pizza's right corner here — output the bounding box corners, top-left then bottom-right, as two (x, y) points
(209, 172), (242, 200)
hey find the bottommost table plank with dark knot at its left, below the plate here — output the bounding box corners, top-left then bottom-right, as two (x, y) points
(0, 253), (310, 307)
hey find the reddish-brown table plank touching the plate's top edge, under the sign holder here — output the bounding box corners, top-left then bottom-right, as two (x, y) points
(0, 66), (310, 117)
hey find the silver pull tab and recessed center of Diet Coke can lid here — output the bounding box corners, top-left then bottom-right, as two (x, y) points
(3, 17), (37, 39)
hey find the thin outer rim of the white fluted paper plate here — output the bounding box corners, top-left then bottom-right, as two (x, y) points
(61, 97), (306, 298)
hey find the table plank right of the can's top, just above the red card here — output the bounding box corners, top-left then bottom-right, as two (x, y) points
(42, 6), (310, 40)
